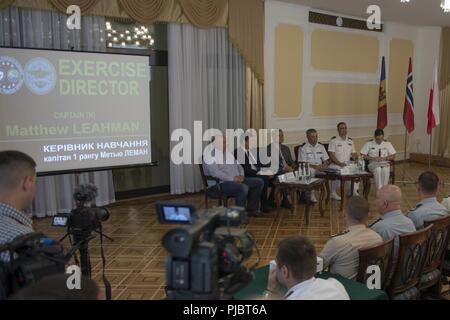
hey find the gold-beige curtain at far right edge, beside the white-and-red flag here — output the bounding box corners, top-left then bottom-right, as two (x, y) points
(433, 27), (450, 157)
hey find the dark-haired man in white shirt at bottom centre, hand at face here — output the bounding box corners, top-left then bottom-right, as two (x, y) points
(265, 236), (350, 300)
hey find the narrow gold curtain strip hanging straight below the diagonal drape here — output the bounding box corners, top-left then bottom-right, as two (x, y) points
(245, 67), (265, 130)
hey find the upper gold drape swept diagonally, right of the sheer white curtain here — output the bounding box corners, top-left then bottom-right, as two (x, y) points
(228, 0), (264, 83)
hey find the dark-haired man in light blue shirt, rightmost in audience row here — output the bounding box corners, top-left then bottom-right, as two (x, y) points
(407, 171), (449, 229)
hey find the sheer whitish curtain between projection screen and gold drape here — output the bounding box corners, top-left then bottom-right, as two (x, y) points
(168, 23), (246, 194)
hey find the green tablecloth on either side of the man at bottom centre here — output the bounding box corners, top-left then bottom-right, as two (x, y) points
(234, 266), (388, 300)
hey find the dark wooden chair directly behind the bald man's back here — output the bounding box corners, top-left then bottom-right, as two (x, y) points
(387, 226), (432, 300)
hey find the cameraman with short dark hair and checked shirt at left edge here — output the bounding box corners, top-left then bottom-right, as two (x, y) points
(0, 151), (36, 261)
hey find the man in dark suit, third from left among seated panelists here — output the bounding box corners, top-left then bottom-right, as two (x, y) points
(267, 129), (296, 209)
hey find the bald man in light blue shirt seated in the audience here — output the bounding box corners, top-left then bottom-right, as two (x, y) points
(370, 185), (416, 264)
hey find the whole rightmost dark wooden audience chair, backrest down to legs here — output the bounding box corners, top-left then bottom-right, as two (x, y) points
(419, 215), (450, 297)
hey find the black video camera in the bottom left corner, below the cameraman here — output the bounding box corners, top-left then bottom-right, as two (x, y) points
(0, 233), (66, 300)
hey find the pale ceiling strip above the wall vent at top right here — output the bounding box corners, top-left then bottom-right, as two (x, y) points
(277, 0), (450, 26)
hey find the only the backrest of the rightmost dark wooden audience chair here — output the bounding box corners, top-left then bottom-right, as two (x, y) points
(423, 215), (450, 273)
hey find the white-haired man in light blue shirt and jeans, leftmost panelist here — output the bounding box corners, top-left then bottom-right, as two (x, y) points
(203, 136), (264, 216)
